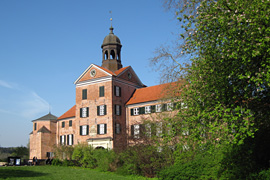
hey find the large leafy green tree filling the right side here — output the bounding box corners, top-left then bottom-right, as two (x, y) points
(152, 0), (270, 179)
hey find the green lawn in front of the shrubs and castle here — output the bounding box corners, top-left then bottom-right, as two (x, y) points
(0, 166), (156, 180)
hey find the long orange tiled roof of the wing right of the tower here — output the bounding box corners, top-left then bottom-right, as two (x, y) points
(126, 82), (181, 105)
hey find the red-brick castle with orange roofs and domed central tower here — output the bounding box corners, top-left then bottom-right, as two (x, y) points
(30, 27), (177, 159)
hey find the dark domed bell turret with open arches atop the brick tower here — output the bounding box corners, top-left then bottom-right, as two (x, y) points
(101, 26), (123, 72)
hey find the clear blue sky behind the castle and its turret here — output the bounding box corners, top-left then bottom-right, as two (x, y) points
(0, 0), (178, 147)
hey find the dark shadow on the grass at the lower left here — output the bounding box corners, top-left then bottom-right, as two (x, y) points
(0, 167), (47, 179)
